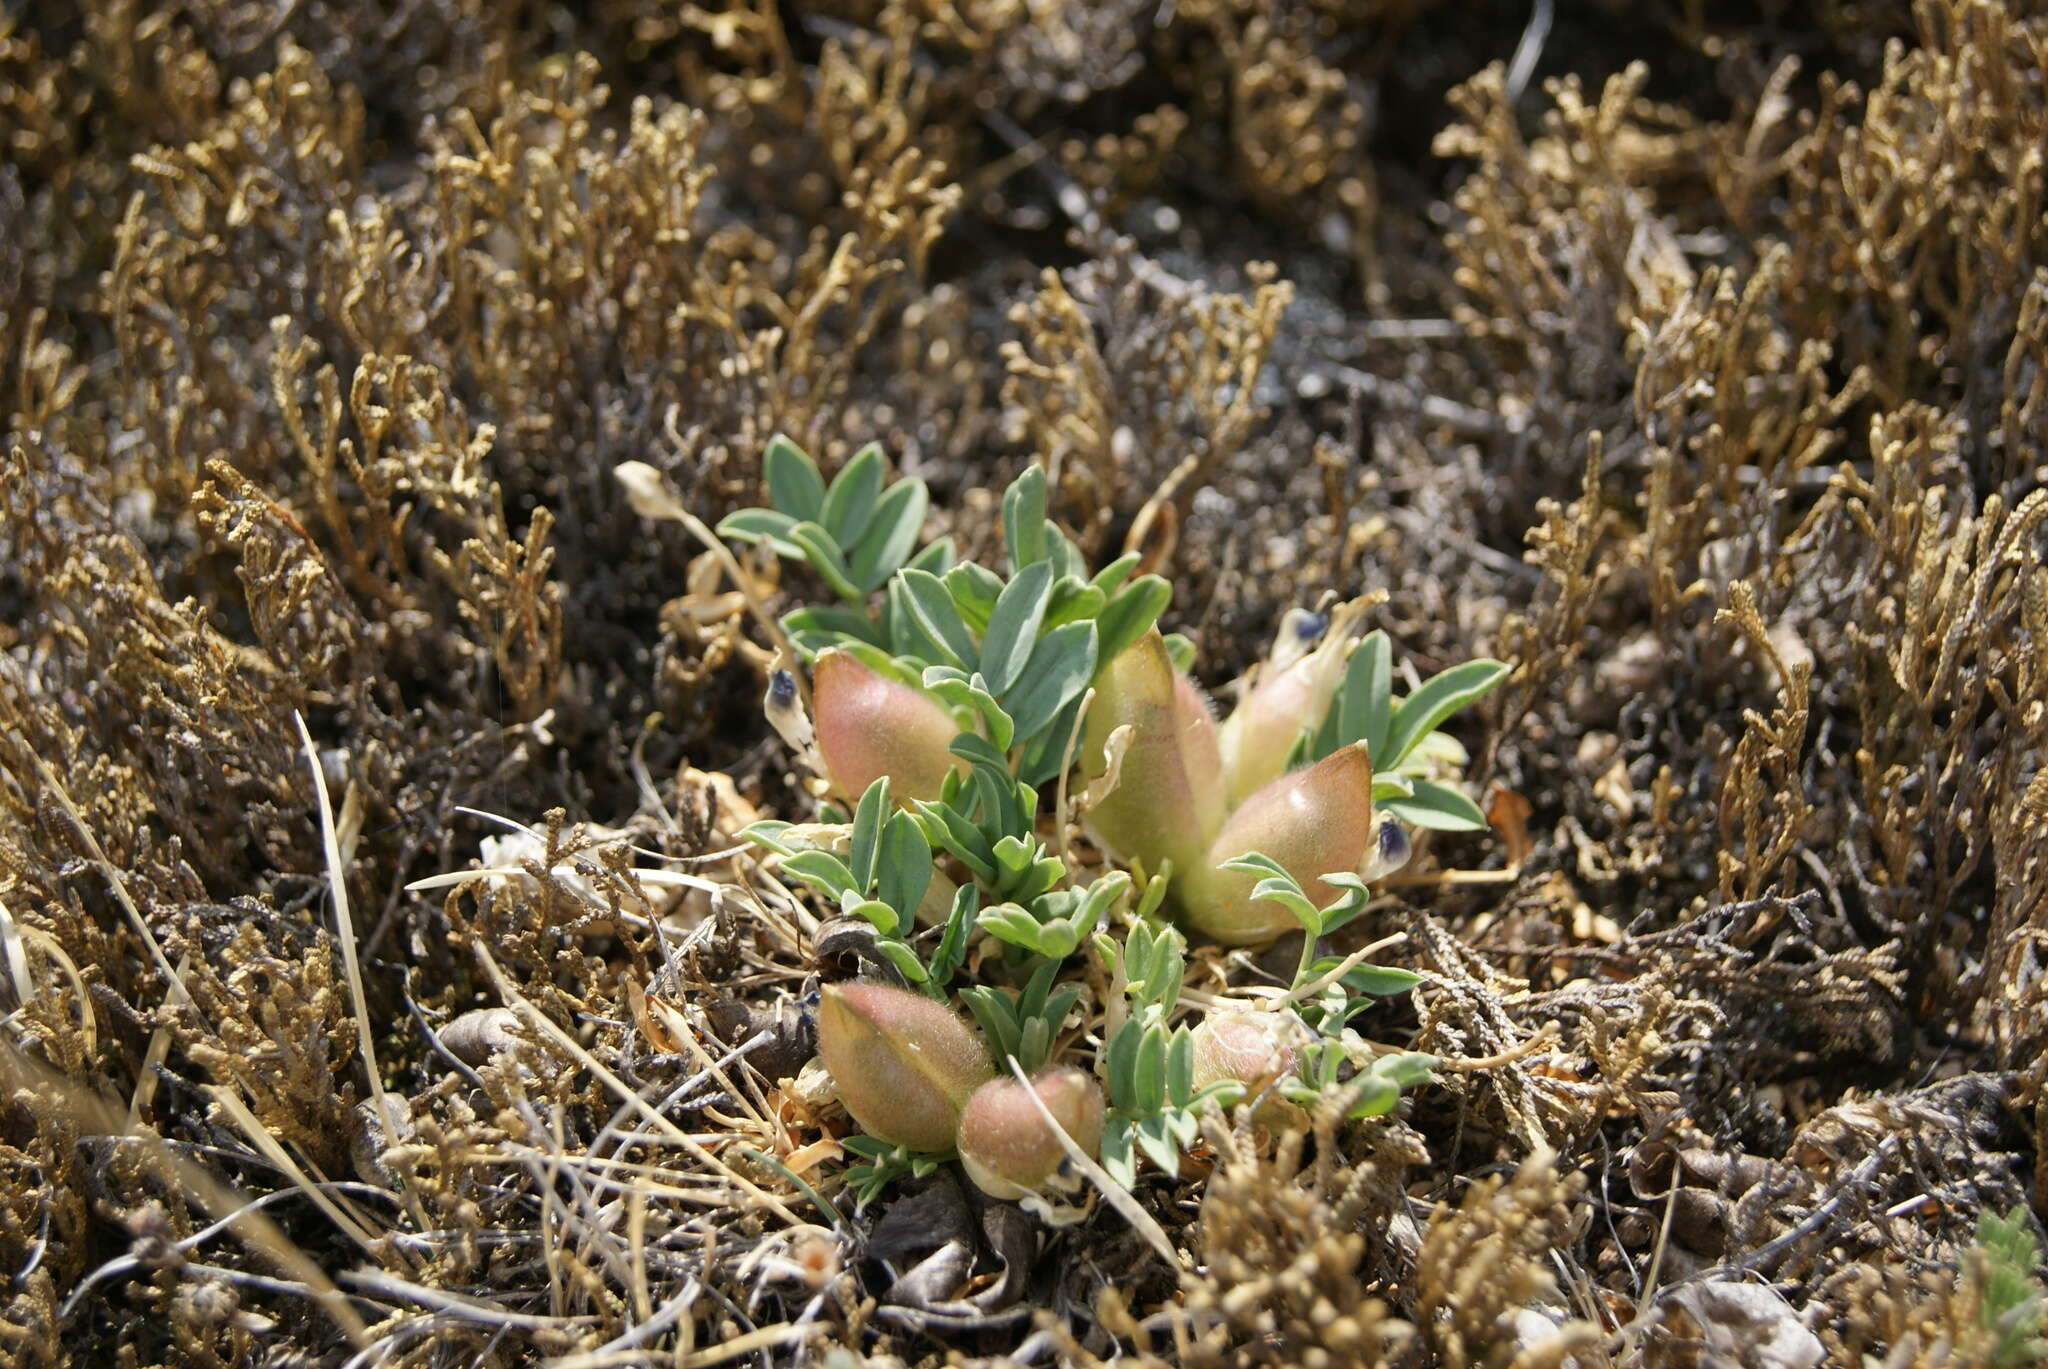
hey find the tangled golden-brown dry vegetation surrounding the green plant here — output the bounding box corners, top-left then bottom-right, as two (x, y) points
(0, 0), (2048, 1369)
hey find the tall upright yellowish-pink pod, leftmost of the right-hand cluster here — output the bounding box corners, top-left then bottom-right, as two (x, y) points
(1081, 631), (1223, 871)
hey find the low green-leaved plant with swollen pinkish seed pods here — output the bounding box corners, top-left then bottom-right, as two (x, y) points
(719, 439), (1507, 1201)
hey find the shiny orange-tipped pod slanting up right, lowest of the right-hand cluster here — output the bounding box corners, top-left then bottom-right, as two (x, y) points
(1176, 742), (1378, 947)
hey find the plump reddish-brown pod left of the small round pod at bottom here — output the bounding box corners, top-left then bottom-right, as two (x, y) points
(817, 982), (995, 1152)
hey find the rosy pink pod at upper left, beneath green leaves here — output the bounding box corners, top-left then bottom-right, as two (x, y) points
(811, 650), (965, 803)
